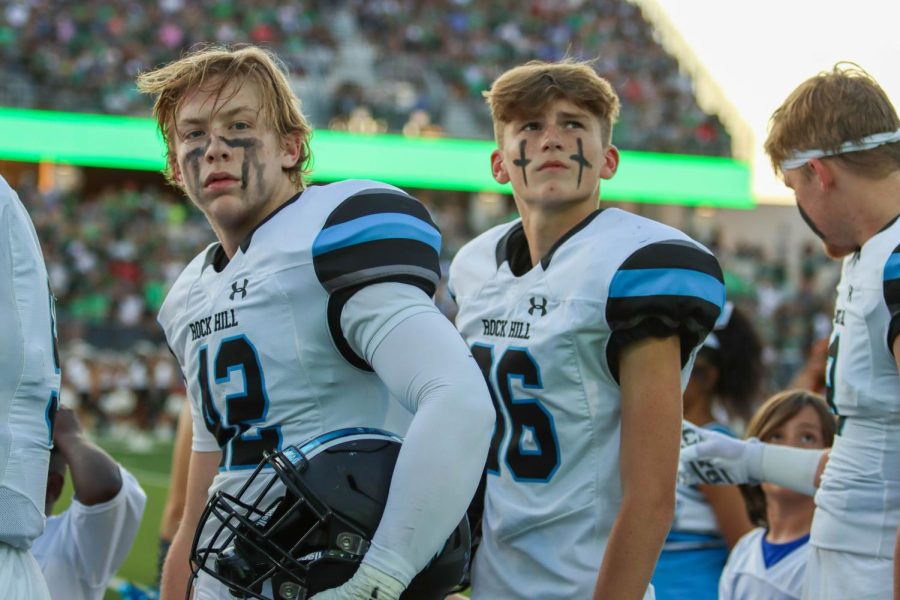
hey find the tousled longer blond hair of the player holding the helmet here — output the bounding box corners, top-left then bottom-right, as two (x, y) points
(137, 45), (312, 189)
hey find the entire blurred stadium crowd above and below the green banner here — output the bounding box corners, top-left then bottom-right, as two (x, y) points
(0, 0), (808, 446)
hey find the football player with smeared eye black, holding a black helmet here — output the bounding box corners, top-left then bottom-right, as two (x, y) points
(138, 46), (494, 600)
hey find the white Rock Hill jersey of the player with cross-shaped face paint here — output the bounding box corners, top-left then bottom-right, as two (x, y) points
(450, 208), (725, 600)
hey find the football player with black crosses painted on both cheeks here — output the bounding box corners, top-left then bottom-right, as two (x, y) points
(450, 61), (725, 600)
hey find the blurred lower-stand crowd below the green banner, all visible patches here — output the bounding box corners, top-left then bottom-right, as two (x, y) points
(19, 181), (839, 447)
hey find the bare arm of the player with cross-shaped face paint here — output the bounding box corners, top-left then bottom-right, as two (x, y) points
(594, 336), (681, 600)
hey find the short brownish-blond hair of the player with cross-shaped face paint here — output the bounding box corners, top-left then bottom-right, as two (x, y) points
(483, 59), (619, 147)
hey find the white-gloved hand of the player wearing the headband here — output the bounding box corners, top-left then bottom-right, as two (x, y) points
(678, 421), (763, 485)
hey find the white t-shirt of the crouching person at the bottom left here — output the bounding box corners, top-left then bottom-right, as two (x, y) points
(32, 466), (147, 600)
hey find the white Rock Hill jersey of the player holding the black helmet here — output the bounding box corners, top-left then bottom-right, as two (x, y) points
(159, 181), (440, 504)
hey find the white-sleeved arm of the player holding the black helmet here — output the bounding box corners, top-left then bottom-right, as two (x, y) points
(364, 311), (495, 584)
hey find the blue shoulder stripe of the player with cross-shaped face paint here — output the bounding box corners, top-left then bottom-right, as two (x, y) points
(609, 269), (725, 307)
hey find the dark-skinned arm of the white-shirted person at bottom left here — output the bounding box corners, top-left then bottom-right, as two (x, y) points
(53, 407), (122, 506)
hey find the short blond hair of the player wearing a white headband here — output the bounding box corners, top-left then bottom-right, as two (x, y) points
(765, 63), (900, 179)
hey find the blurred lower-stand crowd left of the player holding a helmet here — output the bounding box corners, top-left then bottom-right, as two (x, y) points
(18, 183), (211, 450)
